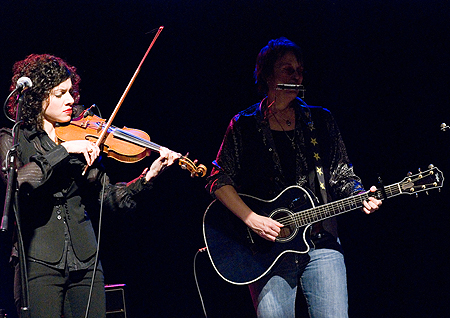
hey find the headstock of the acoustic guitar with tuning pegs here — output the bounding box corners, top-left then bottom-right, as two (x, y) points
(399, 165), (444, 194)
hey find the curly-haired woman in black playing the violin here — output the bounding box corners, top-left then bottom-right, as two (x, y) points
(0, 54), (180, 318)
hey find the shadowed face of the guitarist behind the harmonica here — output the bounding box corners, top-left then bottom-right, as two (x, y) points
(267, 52), (303, 94)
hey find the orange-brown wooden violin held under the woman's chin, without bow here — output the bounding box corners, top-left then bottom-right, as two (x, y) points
(55, 110), (207, 177)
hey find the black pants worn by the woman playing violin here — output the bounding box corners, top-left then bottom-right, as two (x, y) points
(15, 262), (106, 318)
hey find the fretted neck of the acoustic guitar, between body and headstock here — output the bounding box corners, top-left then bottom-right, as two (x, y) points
(294, 183), (403, 227)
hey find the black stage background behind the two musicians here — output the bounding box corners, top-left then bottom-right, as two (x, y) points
(0, 0), (450, 318)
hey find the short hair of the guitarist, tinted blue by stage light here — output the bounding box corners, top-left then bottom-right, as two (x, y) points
(254, 37), (303, 95)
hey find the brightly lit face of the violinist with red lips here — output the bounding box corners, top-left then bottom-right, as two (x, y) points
(42, 78), (74, 125)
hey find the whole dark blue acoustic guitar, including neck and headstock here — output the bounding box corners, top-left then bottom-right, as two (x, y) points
(203, 165), (444, 285)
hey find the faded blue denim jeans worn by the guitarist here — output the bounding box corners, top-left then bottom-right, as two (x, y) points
(249, 248), (348, 318)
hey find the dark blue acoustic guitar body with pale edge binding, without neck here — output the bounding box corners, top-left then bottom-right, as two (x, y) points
(203, 186), (317, 285)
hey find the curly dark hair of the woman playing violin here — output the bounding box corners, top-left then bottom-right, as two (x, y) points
(8, 54), (80, 129)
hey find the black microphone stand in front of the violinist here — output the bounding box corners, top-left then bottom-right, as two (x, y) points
(0, 89), (30, 318)
